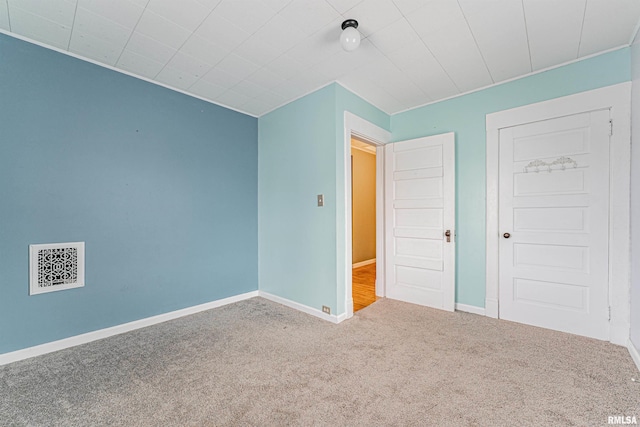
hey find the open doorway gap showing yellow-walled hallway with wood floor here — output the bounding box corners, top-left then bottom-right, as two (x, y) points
(351, 136), (377, 312)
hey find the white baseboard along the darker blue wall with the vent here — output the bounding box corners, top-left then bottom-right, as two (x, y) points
(0, 291), (258, 366)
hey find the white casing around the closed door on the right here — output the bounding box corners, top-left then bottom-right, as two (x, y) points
(485, 82), (631, 345)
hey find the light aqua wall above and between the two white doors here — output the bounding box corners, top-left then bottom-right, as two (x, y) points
(391, 48), (631, 307)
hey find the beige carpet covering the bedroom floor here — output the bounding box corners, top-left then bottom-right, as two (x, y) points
(0, 298), (640, 426)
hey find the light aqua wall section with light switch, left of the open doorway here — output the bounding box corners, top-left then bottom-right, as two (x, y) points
(258, 84), (389, 314)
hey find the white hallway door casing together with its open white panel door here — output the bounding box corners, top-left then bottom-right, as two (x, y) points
(344, 112), (456, 319)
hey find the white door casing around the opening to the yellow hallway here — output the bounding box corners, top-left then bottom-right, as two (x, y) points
(337, 111), (391, 319)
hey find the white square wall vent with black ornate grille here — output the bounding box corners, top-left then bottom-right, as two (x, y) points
(29, 242), (84, 295)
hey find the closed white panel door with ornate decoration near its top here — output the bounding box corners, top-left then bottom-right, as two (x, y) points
(499, 110), (609, 340)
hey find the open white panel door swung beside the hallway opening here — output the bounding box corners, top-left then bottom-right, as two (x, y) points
(385, 133), (455, 311)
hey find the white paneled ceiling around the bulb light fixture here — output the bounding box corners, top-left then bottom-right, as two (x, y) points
(0, 0), (640, 116)
